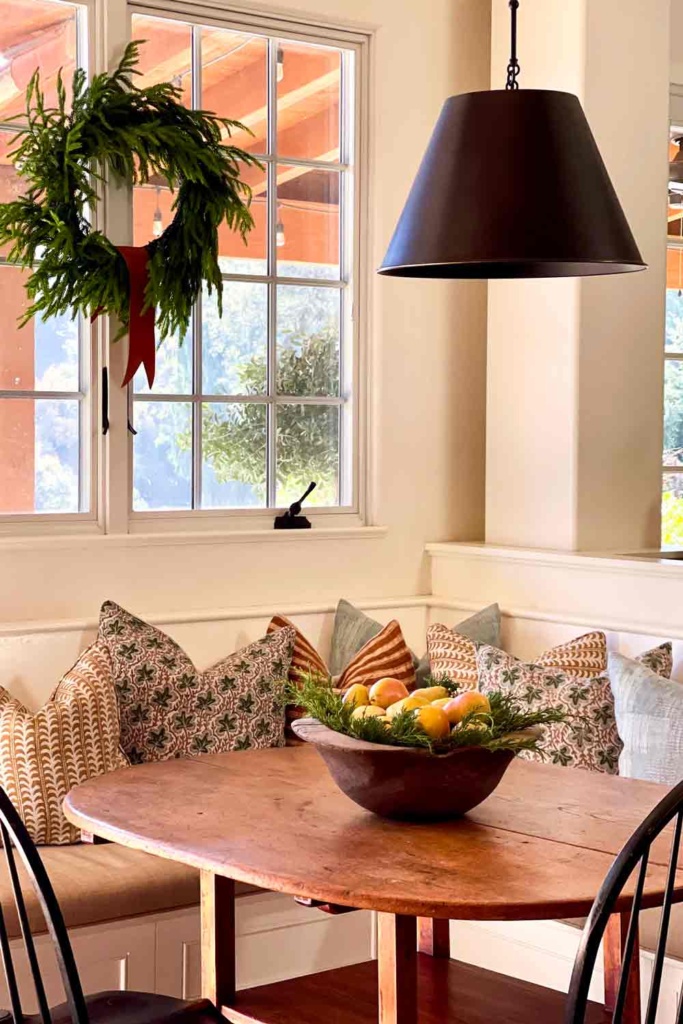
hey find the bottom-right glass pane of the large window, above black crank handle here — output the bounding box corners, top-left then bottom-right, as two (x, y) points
(276, 404), (339, 507)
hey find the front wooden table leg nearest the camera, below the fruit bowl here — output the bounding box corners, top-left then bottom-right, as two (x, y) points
(377, 913), (418, 1024)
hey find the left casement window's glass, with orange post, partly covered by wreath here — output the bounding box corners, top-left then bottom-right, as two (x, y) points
(0, 0), (91, 518)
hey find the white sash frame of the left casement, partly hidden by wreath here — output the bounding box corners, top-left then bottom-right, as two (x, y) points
(0, 0), (100, 537)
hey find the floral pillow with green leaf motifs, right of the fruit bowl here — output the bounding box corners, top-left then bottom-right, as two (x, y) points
(476, 637), (621, 775)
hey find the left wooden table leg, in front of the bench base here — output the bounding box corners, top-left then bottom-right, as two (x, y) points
(201, 870), (236, 1008)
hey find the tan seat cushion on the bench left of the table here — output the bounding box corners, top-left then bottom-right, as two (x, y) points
(0, 843), (255, 938)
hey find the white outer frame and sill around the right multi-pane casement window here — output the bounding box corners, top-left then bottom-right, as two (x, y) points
(0, 0), (373, 541)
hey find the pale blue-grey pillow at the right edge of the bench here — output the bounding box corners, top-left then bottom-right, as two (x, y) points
(608, 653), (683, 785)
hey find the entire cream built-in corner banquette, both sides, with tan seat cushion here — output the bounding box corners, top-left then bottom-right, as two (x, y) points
(5, 593), (683, 1019)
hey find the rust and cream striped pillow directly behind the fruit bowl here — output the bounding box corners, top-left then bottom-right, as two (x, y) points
(268, 615), (416, 690)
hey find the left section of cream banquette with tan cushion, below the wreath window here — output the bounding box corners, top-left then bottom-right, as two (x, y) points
(0, 599), (427, 1008)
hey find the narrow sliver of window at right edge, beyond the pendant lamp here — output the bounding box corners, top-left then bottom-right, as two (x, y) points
(661, 127), (683, 549)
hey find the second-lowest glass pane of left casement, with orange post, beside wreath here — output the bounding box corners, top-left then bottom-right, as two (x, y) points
(0, 266), (79, 391)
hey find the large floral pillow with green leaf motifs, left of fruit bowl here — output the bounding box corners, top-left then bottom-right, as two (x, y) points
(99, 601), (295, 764)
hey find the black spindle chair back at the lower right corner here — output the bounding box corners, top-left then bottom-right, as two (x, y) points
(565, 782), (683, 1024)
